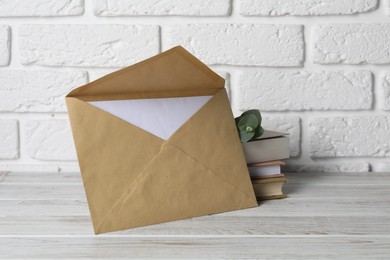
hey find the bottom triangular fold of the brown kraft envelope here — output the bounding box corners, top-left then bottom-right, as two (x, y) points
(95, 143), (253, 234)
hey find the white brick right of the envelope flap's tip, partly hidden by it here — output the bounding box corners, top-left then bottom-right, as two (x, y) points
(167, 24), (304, 66)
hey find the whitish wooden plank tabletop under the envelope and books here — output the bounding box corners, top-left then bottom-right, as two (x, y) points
(0, 172), (390, 259)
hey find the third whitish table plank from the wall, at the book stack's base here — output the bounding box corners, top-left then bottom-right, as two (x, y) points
(0, 198), (390, 217)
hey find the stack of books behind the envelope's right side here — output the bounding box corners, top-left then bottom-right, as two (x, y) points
(242, 130), (290, 200)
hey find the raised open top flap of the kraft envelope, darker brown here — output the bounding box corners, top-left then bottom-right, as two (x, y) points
(68, 46), (224, 100)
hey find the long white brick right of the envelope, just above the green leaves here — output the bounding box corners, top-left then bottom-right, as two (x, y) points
(238, 70), (372, 111)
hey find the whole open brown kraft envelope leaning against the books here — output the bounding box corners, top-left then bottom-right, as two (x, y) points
(66, 47), (257, 234)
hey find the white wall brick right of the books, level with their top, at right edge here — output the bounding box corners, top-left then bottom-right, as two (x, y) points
(310, 116), (390, 158)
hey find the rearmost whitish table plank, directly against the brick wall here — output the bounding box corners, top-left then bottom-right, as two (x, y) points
(0, 172), (390, 185)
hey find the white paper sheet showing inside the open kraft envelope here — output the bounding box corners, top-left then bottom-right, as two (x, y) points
(88, 96), (211, 140)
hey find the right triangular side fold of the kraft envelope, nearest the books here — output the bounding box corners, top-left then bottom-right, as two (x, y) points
(167, 89), (255, 200)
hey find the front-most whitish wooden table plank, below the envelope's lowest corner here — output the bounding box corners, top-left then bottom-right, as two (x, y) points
(0, 236), (390, 259)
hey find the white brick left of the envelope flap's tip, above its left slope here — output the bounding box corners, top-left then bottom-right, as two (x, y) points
(19, 24), (160, 67)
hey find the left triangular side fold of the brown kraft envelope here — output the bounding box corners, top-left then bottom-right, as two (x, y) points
(66, 98), (163, 229)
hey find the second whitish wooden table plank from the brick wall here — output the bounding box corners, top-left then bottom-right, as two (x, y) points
(0, 183), (390, 200)
